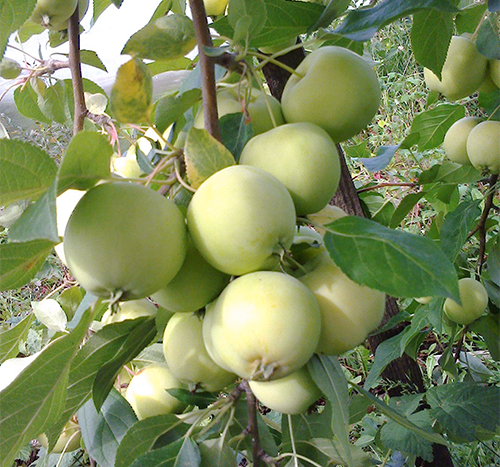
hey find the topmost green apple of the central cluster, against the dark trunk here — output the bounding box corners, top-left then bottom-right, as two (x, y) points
(281, 46), (380, 143)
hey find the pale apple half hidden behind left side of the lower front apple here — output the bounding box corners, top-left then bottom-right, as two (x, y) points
(163, 313), (236, 392)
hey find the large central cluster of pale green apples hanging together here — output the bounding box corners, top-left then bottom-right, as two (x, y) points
(57, 47), (385, 418)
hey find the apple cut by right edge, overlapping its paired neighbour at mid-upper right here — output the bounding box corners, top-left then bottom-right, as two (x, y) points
(467, 120), (500, 174)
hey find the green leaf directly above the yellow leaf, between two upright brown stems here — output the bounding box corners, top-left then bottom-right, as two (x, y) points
(121, 14), (196, 60)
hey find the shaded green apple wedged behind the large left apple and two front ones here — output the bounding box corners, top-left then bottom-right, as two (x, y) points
(151, 236), (230, 312)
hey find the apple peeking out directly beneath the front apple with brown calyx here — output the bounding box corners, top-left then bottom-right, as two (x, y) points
(249, 366), (322, 415)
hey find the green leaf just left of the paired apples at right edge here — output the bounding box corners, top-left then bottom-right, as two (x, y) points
(410, 104), (465, 151)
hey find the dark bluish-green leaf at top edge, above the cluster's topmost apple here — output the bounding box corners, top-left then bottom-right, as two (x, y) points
(334, 0), (459, 41)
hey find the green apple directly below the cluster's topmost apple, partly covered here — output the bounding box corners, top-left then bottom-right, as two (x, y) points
(240, 122), (340, 215)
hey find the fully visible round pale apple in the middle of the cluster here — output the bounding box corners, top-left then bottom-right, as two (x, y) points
(187, 165), (295, 276)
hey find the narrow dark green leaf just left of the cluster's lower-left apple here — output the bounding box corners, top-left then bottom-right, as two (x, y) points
(92, 317), (156, 410)
